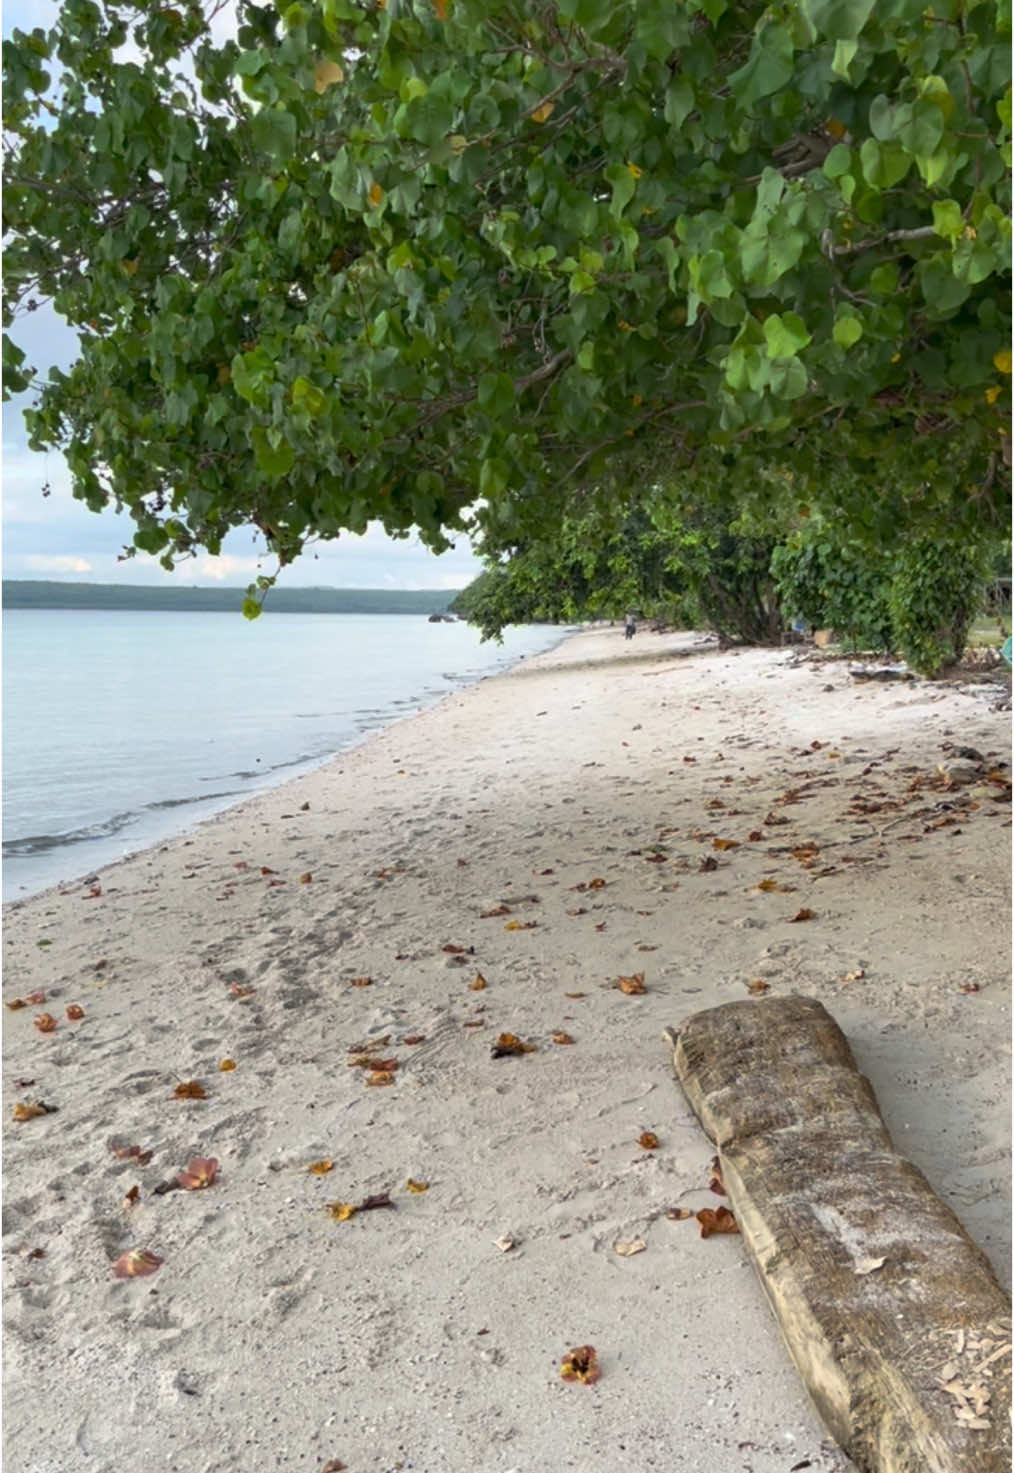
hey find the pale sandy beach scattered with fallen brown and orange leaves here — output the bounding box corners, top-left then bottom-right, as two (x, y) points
(3, 629), (1011, 1473)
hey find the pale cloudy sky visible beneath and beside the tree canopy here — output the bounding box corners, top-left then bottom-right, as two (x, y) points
(3, 0), (480, 588)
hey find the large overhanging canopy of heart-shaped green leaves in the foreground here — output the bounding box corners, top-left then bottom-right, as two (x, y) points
(3, 0), (1011, 609)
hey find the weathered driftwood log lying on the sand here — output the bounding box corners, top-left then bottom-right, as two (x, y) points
(668, 997), (1011, 1473)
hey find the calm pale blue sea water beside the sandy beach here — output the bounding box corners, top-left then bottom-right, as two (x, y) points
(3, 608), (564, 900)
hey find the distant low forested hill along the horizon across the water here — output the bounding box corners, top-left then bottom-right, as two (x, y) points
(3, 579), (460, 614)
